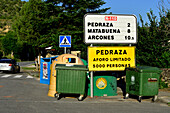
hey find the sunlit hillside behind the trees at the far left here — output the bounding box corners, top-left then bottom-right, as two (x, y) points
(0, 0), (25, 57)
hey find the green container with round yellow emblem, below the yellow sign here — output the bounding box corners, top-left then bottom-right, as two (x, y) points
(88, 71), (117, 96)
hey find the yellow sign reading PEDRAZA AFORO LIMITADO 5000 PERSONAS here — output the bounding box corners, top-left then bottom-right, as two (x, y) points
(88, 47), (135, 71)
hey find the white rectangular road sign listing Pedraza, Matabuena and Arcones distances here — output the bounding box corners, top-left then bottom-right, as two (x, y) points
(84, 14), (137, 44)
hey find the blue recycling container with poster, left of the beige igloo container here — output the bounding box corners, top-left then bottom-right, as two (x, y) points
(40, 56), (58, 85)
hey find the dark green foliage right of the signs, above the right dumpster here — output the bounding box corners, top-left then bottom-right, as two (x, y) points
(136, 10), (170, 68)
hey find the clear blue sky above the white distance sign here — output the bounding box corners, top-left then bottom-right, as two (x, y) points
(23, 0), (170, 25)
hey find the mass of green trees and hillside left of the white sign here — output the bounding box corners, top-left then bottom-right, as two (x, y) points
(0, 0), (109, 59)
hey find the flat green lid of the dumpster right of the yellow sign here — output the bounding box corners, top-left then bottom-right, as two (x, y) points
(126, 66), (162, 73)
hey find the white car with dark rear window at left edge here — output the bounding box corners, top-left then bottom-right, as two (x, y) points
(0, 59), (20, 73)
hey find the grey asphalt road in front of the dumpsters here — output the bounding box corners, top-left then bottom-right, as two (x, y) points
(0, 72), (170, 113)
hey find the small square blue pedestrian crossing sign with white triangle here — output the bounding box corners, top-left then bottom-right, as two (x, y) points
(59, 35), (71, 47)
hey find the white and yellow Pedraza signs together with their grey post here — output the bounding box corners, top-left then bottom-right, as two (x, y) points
(84, 14), (137, 97)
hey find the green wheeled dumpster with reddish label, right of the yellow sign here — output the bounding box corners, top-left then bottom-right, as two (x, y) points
(125, 66), (161, 102)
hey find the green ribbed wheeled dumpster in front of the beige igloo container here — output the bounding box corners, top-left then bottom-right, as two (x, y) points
(55, 64), (87, 100)
